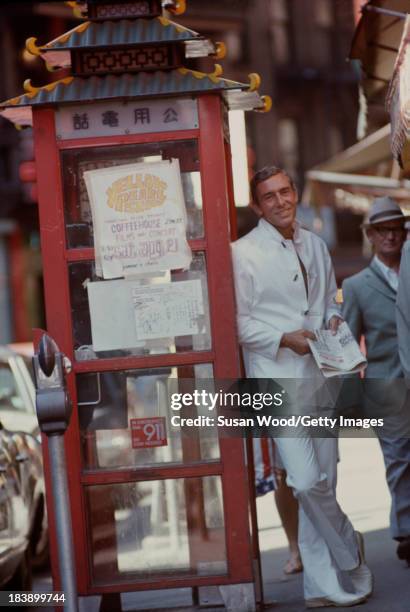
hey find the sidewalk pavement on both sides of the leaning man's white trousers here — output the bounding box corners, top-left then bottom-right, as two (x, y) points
(257, 438), (410, 612)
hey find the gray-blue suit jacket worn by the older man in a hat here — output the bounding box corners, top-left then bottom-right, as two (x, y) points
(343, 262), (403, 378)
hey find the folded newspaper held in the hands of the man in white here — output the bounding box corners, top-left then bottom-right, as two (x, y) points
(308, 322), (367, 378)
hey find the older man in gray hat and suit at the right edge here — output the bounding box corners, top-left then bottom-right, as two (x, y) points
(343, 197), (410, 560)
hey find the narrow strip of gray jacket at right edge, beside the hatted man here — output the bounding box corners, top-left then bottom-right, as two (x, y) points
(396, 240), (410, 379)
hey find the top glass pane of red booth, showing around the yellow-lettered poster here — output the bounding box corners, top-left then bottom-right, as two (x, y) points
(61, 140), (204, 249)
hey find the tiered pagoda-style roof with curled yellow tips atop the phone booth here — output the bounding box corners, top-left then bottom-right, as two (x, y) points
(0, 0), (271, 125)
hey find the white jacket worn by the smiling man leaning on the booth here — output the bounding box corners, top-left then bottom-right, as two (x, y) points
(232, 219), (339, 378)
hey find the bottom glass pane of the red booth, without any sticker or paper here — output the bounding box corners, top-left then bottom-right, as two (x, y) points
(86, 476), (227, 585)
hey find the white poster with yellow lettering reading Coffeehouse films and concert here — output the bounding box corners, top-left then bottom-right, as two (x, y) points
(84, 159), (192, 279)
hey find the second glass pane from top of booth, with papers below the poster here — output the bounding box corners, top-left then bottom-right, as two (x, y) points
(69, 253), (211, 361)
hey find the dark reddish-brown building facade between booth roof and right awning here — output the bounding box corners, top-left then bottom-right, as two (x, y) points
(176, 0), (359, 187)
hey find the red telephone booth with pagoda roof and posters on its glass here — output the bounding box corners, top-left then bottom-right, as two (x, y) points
(2, 0), (269, 611)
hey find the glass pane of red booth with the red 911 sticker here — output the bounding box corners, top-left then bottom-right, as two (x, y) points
(77, 364), (220, 470)
